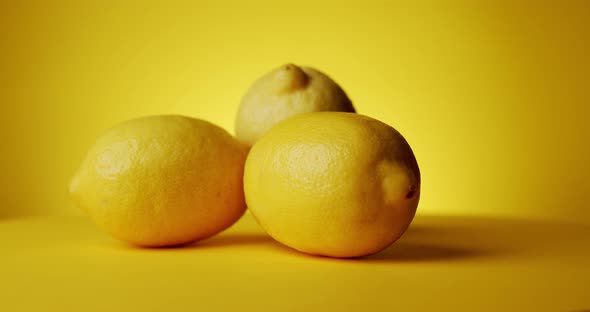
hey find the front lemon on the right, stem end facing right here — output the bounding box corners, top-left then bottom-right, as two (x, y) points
(244, 112), (420, 257)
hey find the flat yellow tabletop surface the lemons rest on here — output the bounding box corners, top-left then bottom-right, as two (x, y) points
(0, 215), (590, 312)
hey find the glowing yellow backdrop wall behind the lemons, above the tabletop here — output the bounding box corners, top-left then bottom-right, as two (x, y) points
(0, 0), (590, 221)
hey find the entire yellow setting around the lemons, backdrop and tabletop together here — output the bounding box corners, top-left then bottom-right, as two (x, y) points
(0, 0), (590, 311)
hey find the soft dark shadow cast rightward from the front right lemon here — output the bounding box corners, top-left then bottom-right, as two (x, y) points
(360, 216), (588, 262)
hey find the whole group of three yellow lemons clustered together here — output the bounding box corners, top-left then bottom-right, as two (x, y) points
(70, 64), (420, 257)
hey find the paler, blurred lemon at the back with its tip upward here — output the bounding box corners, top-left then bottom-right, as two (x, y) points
(235, 64), (355, 145)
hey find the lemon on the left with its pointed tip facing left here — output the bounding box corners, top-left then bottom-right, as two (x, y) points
(70, 115), (247, 247)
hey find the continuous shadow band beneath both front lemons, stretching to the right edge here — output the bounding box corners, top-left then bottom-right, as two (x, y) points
(103, 214), (590, 263)
